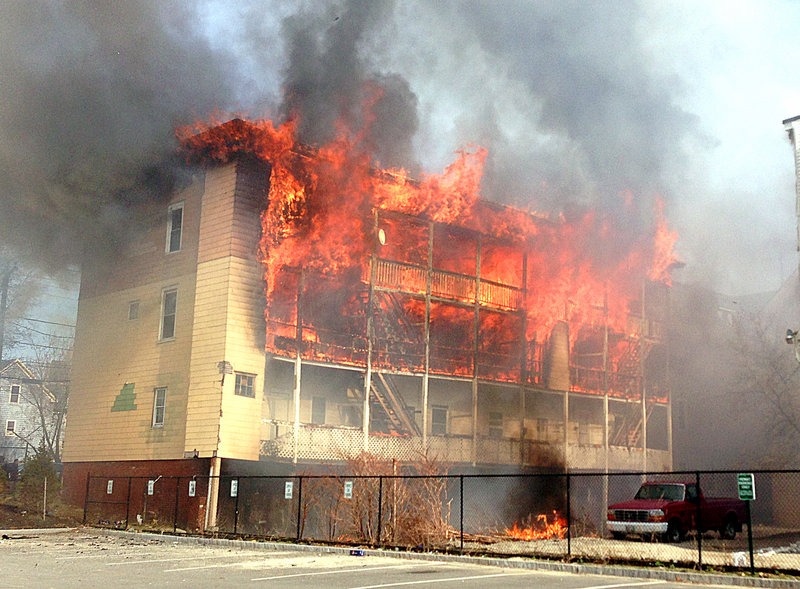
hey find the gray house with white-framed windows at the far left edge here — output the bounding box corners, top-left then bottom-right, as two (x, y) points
(0, 359), (56, 462)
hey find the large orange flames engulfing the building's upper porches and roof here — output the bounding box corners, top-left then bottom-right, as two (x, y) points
(178, 110), (676, 396)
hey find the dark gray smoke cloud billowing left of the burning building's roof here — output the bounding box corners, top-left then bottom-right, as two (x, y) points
(0, 1), (245, 268)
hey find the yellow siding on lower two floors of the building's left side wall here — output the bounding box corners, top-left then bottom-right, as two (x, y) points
(64, 275), (194, 462)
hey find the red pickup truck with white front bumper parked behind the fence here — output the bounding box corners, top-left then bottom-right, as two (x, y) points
(606, 482), (745, 542)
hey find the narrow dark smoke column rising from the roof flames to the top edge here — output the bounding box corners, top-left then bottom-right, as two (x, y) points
(282, 0), (419, 172)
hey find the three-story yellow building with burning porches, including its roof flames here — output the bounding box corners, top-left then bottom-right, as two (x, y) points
(64, 119), (674, 520)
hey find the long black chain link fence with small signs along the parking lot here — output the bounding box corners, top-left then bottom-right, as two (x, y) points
(84, 470), (800, 574)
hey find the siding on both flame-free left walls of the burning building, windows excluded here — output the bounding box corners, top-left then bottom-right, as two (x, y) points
(64, 163), (268, 462)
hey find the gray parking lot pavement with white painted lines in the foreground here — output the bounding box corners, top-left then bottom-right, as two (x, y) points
(0, 529), (785, 589)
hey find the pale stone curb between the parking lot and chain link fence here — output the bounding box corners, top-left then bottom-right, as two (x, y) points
(98, 528), (800, 589)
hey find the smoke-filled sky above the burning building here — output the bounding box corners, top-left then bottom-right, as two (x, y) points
(0, 0), (800, 308)
